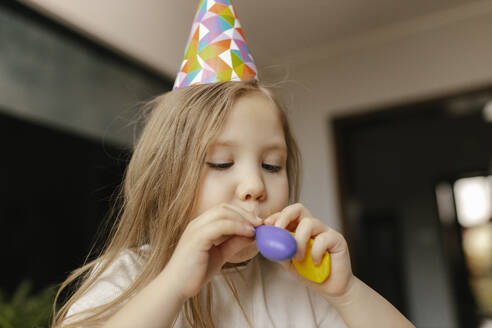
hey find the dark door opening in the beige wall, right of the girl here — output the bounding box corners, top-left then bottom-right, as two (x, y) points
(330, 88), (492, 327)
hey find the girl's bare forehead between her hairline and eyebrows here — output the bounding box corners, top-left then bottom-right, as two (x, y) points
(212, 92), (286, 150)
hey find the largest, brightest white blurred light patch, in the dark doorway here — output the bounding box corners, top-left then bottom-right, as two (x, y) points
(454, 176), (492, 227)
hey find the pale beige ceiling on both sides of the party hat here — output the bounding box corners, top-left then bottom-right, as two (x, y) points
(21, 0), (475, 78)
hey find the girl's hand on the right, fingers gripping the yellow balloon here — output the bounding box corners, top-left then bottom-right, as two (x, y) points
(264, 203), (355, 297)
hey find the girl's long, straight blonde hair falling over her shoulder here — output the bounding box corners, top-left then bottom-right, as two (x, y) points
(52, 80), (300, 328)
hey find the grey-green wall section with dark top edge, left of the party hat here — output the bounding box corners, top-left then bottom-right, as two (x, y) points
(0, 2), (171, 145)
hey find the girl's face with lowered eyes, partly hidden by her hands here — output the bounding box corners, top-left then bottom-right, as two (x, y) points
(192, 92), (289, 263)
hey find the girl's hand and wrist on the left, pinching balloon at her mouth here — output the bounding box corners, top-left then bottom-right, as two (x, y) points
(161, 204), (261, 299)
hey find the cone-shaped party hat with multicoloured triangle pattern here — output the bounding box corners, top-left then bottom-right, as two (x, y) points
(173, 0), (257, 89)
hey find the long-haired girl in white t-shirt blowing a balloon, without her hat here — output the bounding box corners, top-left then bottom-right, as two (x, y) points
(52, 80), (413, 328)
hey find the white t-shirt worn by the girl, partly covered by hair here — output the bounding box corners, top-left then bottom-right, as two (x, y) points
(68, 250), (346, 328)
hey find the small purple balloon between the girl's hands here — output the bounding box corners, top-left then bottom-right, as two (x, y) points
(255, 225), (297, 261)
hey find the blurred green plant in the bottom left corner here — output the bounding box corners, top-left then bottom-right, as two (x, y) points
(0, 280), (56, 328)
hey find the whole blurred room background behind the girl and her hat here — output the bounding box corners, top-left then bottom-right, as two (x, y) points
(0, 0), (492, 328)
